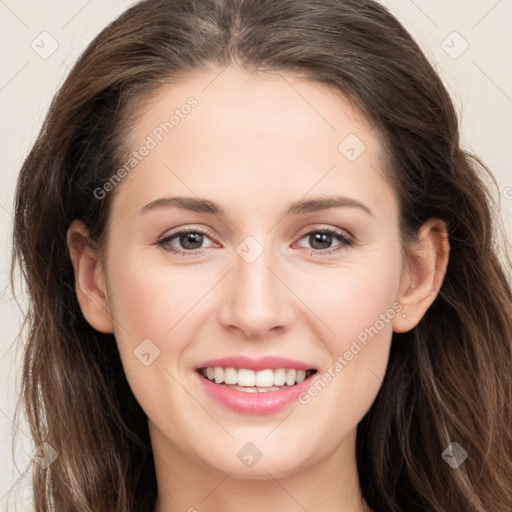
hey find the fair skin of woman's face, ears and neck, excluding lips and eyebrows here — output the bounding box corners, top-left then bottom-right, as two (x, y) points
(68, 67), (448, 512)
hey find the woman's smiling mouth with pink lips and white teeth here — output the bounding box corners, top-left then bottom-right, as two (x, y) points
(196, 356), (316, 414)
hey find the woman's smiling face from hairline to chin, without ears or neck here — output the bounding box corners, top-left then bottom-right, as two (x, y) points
(97, 68), (403, 478)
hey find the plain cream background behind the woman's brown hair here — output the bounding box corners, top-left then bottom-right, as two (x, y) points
(0, 0), (512, 511)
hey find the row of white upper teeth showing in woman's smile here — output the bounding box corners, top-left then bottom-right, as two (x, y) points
(202, 366), (312, 386)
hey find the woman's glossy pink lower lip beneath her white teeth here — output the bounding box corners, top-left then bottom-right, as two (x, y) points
(197, 373), (316, 415)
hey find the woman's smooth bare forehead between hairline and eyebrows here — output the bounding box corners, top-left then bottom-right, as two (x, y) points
(111, 67), (393, 222)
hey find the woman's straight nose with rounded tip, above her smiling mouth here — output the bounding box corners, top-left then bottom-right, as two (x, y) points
(220, 247), (293, 341)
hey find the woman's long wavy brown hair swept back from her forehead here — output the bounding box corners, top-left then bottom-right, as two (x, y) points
(12, 0), (512, 512)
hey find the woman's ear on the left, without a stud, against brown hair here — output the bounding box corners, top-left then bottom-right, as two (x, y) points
(67, 219), (114, 333)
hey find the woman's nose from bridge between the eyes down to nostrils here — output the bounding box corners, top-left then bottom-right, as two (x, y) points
(221, 237), (291, 338)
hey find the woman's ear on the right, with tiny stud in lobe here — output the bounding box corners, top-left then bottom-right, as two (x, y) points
(393, 219), (450, 332)
